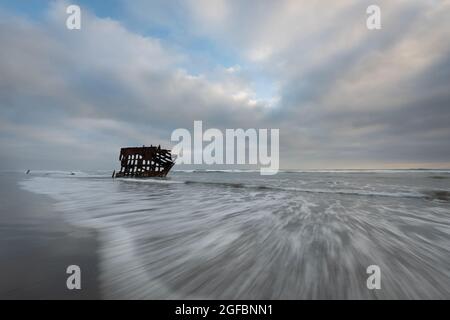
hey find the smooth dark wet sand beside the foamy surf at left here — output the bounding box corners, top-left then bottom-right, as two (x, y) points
(0, 173), (100, 299)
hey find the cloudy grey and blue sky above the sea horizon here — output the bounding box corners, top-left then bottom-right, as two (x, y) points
(0, 0), (450, 170)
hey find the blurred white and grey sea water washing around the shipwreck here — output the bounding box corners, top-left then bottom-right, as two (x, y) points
(20, 170), (450, 299)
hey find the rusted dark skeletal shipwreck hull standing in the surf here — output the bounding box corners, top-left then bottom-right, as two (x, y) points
(113, 146), (175, 178)
